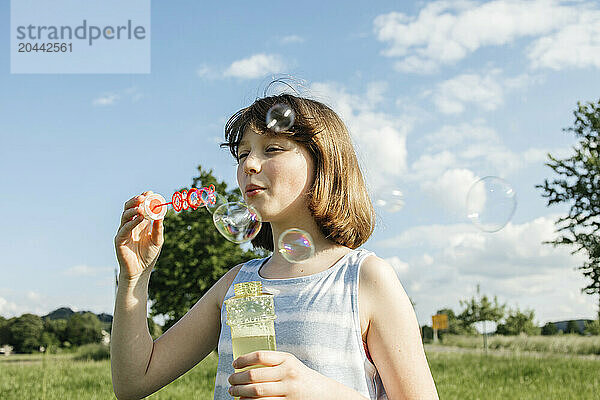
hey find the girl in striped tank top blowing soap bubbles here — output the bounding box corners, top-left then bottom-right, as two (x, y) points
(111, 94), (438, 400)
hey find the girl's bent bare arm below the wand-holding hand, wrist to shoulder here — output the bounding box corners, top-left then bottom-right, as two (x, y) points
(111, 266), (240, 400)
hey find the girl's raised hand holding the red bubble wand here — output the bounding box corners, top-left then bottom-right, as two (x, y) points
(115, 191), (164, 280)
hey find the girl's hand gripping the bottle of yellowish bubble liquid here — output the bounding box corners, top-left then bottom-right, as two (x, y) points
(229, 350), (336, 400)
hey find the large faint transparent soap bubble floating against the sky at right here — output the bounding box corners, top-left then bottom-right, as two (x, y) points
(467, 176), (517, 232)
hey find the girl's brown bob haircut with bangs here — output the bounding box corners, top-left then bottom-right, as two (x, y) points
(220, 93), (375, 251)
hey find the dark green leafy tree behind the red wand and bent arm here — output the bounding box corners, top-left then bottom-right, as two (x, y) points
(149, 166), (265, 330)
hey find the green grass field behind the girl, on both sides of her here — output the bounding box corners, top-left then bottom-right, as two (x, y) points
(0, 346), (600, 400)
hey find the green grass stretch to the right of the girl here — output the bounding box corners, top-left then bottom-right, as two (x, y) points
(427, 351), (600, 400)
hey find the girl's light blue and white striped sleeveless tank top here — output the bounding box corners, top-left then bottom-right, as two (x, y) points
(214, 249), (387, 400)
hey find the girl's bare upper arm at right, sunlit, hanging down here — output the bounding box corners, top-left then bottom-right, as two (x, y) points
(360, 256), (438, 400)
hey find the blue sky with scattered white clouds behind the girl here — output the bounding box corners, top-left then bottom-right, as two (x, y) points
(0, 0), (600, 324)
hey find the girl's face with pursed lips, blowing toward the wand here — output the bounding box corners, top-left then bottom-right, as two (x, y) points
(237, 129), (314, 222)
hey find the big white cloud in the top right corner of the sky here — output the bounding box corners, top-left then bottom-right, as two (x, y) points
(373, 0), (600, 73)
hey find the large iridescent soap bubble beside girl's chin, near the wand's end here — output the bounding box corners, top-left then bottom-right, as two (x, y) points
(213, 202), (262, 243)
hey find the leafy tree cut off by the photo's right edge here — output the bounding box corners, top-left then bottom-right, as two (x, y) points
(536, 100), (600, 320)
